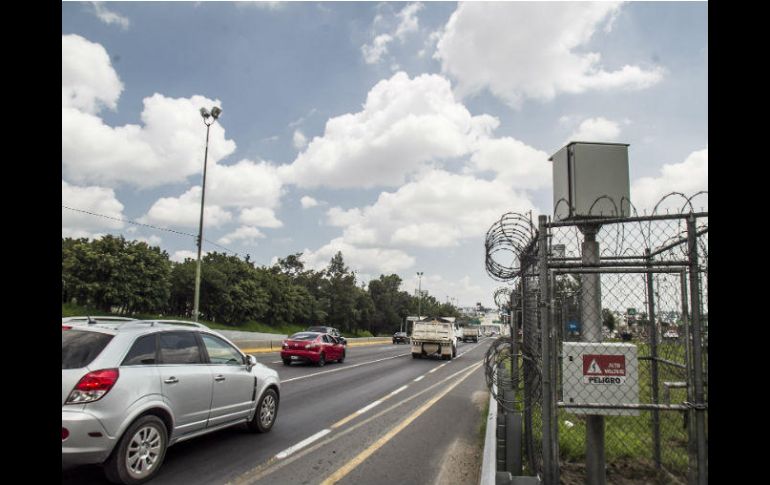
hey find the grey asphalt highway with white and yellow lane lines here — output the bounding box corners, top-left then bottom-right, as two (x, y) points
(62, 339), (490, 485)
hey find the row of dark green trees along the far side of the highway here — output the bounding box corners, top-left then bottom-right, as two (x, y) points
(62, 235), (460, 337)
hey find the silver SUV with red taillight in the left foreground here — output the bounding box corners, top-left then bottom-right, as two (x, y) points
(61, 320), (280, 484)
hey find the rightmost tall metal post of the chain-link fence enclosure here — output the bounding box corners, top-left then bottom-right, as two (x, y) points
(687, 213), (708, 485)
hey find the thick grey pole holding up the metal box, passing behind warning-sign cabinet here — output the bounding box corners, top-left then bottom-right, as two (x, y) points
(578, 225), (607, 485)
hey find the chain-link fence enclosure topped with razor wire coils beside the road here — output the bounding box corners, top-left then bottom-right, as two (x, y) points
(487, 192), (708, 483)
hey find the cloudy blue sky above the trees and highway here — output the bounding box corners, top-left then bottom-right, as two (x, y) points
(62, 2), (708, 306)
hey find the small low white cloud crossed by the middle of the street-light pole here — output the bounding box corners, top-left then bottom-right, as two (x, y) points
(139, 185), (233, 229)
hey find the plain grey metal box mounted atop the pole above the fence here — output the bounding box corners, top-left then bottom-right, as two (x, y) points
(549, 141), (631, 221)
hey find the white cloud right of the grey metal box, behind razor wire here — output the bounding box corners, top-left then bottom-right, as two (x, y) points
(631, 148), (708, 213)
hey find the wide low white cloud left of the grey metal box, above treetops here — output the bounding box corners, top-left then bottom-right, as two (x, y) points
(327, 170), (533, 248)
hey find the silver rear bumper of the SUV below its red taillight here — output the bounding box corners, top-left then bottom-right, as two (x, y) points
(61, 409), (117, 467)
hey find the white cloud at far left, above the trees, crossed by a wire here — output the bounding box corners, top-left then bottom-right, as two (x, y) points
(61, 180), (125, 238)
